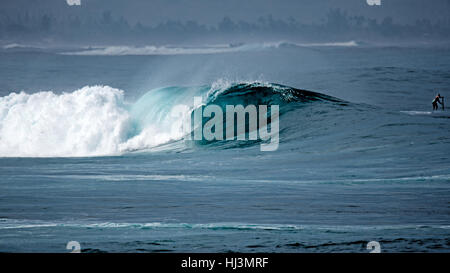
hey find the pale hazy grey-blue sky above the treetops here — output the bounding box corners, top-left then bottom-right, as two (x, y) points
(0, 0), (450, 25)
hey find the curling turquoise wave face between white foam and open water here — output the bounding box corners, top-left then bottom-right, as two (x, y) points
(123, 82), (347, 150)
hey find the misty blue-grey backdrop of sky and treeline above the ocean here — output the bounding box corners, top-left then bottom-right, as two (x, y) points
(0, 0), (450, 46)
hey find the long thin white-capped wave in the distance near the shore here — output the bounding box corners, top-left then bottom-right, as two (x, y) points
(61, 41), (358, 56)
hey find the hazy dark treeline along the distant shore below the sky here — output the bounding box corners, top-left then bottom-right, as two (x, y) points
(0, 9), (450, 44)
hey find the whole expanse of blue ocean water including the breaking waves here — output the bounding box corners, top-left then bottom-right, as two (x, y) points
(0, 42), (450, 252)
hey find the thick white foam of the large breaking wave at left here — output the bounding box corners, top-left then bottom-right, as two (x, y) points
(0, 86), (188, 157)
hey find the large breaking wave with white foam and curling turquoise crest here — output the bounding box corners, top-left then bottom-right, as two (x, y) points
(0, 81), (339, 157)
